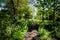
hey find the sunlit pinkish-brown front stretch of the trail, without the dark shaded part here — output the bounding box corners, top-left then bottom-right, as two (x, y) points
(24, 30), (40, 40)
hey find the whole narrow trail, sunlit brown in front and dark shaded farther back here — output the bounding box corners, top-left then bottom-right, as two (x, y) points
(24, 22), (40, 40)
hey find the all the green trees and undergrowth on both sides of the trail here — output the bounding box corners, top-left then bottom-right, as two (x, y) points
(0, 0), (60, 40)
